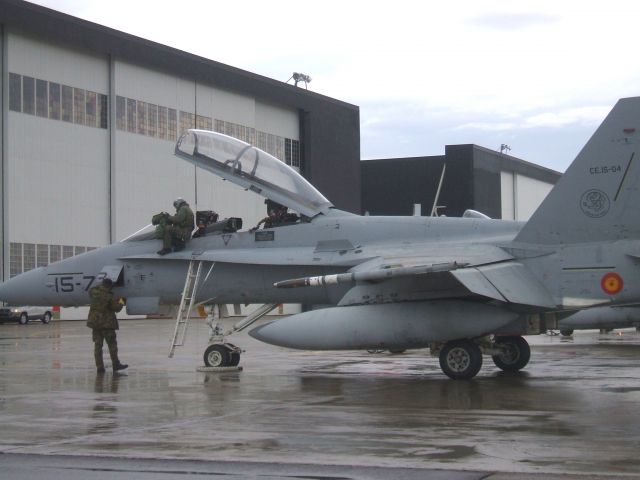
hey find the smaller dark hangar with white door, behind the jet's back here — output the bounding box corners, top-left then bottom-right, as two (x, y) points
(362, 145), (561, 220)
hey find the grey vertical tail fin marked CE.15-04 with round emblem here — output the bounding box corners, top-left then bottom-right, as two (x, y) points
(515, 97), (640, 244)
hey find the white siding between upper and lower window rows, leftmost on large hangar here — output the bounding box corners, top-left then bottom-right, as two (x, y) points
(8, 112), (109, 246)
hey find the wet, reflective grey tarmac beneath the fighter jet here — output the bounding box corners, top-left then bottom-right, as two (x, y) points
(0, 320), (640, 480)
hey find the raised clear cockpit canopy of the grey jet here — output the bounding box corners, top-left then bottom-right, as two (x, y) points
(175, 130), (333, 217)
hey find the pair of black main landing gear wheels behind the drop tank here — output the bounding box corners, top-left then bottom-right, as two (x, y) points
(431, 336), (531, 380)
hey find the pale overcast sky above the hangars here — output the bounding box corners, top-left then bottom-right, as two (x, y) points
(34, 0), (640, 172)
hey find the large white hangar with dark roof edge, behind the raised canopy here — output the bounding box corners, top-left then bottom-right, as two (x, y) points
(0, 0), (360, 280)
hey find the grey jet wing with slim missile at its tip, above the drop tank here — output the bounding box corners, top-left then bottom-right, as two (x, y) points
(275, 245), (556, 309)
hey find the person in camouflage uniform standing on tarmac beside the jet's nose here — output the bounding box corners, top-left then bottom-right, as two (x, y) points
(87, 278), (128, 373)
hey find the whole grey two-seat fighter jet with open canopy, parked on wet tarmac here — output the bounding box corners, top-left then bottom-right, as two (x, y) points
(0, 98), (640, 379)
